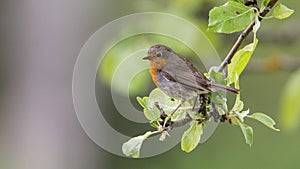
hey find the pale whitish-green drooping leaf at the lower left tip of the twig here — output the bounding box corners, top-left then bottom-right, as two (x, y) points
(122, 131), (157, 158)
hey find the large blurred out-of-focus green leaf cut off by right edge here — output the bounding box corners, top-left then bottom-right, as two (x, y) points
(280, 69), (300, 129)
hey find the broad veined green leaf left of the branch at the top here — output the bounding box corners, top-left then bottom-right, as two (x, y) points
(208, 0), (255, 33)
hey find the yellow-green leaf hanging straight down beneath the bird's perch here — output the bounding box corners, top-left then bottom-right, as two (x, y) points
(181, 121), (203, 153)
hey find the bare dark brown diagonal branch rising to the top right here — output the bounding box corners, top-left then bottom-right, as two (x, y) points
(218, 0), (278, 72)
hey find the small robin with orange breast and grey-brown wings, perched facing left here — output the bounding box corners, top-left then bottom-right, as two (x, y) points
(143, 45), (239, 109)
